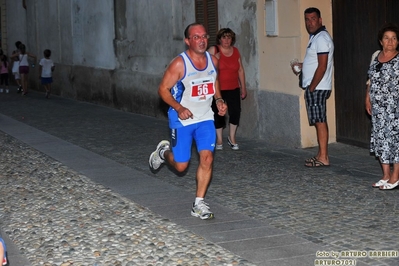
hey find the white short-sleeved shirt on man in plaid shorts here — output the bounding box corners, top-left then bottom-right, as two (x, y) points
(302, 27), (334, 90)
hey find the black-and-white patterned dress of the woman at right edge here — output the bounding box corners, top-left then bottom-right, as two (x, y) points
(368, 52), (399, 164)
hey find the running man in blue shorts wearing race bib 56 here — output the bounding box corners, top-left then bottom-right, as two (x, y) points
(149, 23), (227, 220)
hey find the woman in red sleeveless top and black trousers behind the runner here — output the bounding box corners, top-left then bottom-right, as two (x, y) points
(208, 28), (247, 150)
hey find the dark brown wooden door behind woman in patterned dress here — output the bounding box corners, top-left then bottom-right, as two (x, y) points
(332, 0), (399, 147)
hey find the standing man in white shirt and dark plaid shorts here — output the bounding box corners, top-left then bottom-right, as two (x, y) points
(291, 7), (334, 167)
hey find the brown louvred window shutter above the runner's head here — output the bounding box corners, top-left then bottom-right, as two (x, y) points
(195, 0), (219, 46)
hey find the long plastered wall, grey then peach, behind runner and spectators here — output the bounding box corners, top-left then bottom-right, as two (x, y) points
(6, 0), (335, 147)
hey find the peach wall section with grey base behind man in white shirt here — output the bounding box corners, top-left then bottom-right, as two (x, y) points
(257, 0), (335, 147)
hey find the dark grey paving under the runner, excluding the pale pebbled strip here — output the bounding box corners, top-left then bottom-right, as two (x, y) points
(0, 89), (399, 266)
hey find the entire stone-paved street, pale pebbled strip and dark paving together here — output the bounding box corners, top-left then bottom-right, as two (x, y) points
(0, 91), (399, 266)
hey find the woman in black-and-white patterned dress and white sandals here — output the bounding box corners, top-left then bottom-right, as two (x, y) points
(366, 23), (399, 190)
